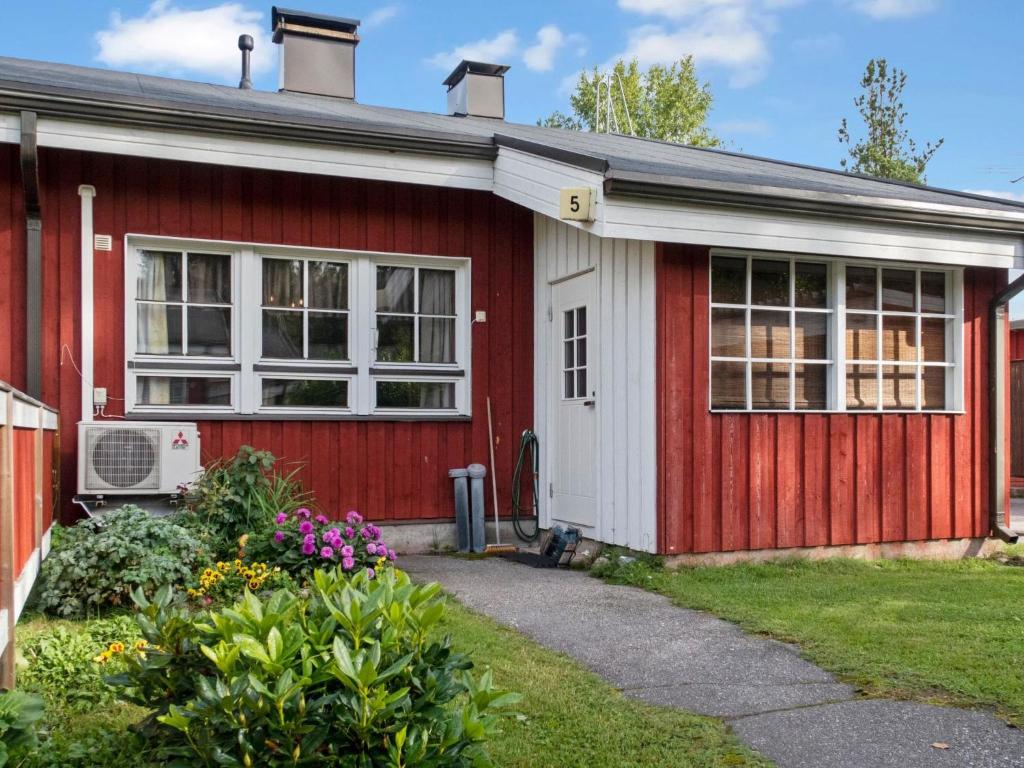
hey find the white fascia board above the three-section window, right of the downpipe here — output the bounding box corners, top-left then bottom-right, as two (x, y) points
(38, 117), (494, 190)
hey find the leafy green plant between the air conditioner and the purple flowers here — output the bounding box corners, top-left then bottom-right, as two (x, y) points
(178, 445), (311, 560)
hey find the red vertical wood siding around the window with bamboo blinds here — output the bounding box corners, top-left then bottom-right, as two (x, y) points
(657, 245), (1006, 554)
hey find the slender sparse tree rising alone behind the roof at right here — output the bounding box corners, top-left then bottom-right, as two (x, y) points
(839, 58), (944, 184)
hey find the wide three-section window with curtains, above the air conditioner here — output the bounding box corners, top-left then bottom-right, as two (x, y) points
(125, 237), (470, 416)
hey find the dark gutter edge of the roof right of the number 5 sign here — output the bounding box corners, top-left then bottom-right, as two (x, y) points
(604, 170), (1024, 236)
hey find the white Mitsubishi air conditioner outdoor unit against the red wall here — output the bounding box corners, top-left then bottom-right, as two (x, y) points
(78, 422), (202, 496)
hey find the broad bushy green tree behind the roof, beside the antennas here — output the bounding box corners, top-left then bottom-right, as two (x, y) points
(538, 56), (722, 146)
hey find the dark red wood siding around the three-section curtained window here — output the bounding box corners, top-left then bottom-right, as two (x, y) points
(0, 145), (534, 520)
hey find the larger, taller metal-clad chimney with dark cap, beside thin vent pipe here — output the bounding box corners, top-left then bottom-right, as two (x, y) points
(270, 6), (359, 98)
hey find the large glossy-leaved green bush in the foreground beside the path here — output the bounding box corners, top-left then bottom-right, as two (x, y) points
(110, 567), (517, 768)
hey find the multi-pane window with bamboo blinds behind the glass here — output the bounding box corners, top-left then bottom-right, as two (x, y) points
(710, 254), (959, 411)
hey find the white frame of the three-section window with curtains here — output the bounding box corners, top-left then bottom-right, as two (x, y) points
(124, 233), (472, 420)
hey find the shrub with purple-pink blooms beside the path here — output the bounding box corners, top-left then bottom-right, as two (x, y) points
(250, 507), (397, 579)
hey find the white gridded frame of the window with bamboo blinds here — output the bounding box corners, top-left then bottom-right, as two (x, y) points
(708, 249), (965, 415)
